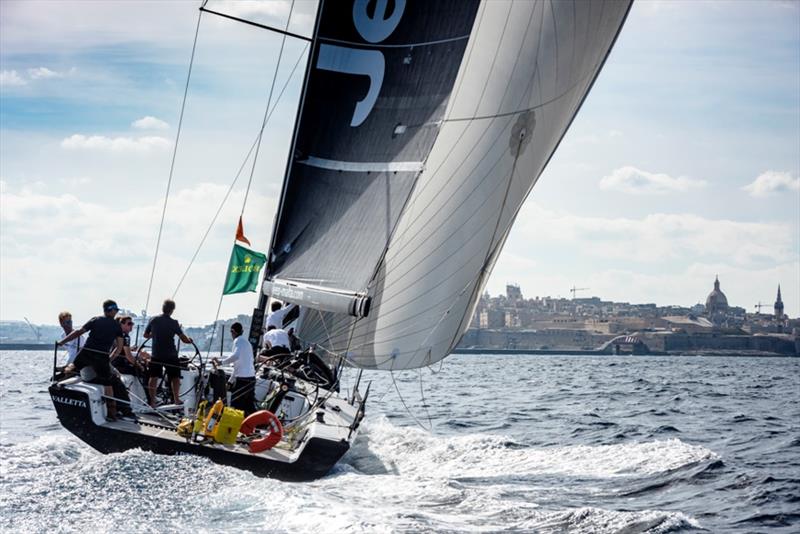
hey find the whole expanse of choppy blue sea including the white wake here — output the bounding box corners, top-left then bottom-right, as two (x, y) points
(0, 352), (800, 534)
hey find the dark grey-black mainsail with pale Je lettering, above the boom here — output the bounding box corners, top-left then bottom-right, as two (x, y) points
(269, 0), (478, 304)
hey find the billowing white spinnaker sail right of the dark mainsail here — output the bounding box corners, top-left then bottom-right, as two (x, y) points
(301, 0), (630, 370)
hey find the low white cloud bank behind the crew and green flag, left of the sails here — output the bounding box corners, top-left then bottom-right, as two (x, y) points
(0, 183), (276, 324)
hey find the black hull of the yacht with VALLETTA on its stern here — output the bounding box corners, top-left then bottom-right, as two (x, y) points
(50, 384), (350, 482)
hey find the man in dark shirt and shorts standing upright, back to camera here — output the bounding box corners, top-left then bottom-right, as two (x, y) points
(144, 299), (192, 408)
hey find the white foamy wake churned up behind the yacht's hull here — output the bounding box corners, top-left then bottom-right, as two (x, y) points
(0, 417), (719, 533)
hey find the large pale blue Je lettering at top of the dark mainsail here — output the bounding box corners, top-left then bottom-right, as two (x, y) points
(317, 0), (406, 128)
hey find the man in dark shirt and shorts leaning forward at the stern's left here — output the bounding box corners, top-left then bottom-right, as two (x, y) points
(58, 300), (122, 420)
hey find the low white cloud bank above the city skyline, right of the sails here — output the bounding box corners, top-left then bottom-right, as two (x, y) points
(489, 203), (800, 316)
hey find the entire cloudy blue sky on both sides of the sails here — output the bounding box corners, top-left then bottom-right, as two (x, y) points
(0, 0), (800, 325)
